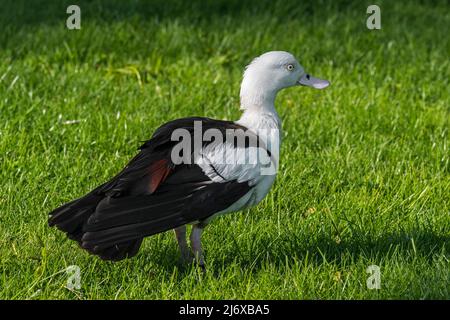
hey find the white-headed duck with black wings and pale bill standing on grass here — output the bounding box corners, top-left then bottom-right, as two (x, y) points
(49, 51), (329, 268)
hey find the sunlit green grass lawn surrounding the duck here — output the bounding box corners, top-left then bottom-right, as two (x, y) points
(0, 0), (450, 299)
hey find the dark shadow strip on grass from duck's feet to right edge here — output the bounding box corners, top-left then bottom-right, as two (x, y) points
(148, 231), (450, 278)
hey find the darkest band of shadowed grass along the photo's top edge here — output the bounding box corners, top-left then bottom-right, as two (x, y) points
(0, 0), (348, 28)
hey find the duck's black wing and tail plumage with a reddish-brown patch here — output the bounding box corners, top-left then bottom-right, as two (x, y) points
(49, 117), (250, 260)
